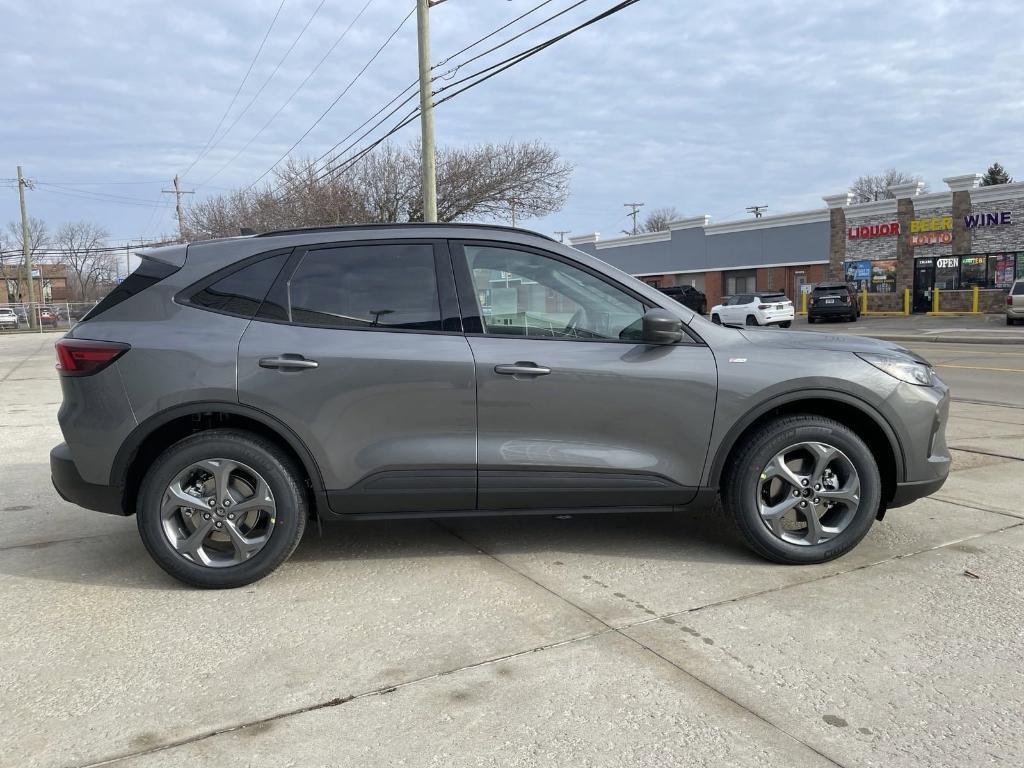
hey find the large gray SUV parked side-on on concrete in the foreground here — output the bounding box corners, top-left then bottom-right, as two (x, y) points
(50, 224), (949, 587)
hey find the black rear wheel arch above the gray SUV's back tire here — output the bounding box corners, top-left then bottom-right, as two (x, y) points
(111, 400), (327, 515)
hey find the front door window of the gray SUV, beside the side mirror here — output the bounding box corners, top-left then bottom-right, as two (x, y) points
(465, 245), (645, 341)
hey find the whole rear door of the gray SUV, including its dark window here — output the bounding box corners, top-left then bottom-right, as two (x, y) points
(238, 240), (476, 513)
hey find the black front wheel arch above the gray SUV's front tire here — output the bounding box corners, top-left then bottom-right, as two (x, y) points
(708, 390), (906, 502)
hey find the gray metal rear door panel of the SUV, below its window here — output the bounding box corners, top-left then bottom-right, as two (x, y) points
(239, 321), (476, 513)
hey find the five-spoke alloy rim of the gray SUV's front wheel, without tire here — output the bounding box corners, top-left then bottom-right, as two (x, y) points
(756, 441), (860, 546)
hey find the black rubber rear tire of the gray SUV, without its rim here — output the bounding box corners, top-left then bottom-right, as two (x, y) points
(136, 429), (309, 589)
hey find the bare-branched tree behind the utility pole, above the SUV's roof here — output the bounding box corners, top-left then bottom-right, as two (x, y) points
(184, 142), (572, 240)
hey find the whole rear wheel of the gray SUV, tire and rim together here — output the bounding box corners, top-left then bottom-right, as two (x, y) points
(136, 429), (308, 588)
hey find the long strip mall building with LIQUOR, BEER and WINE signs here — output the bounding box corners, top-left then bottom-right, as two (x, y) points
(569, 174), (1024, 311)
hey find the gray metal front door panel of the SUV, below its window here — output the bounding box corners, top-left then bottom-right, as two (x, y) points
(469, 337), (718, 509)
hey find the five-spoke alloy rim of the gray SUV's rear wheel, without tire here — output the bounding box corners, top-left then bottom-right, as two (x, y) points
(160, 459), (278, 568)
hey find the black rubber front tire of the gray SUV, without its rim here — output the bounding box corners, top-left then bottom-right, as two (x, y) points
(722, 415), (882, 565)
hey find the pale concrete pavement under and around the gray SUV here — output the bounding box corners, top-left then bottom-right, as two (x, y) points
(0, 331), (1024, 768)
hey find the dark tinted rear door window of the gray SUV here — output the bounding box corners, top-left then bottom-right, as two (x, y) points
(288, 244), (441, 331)
